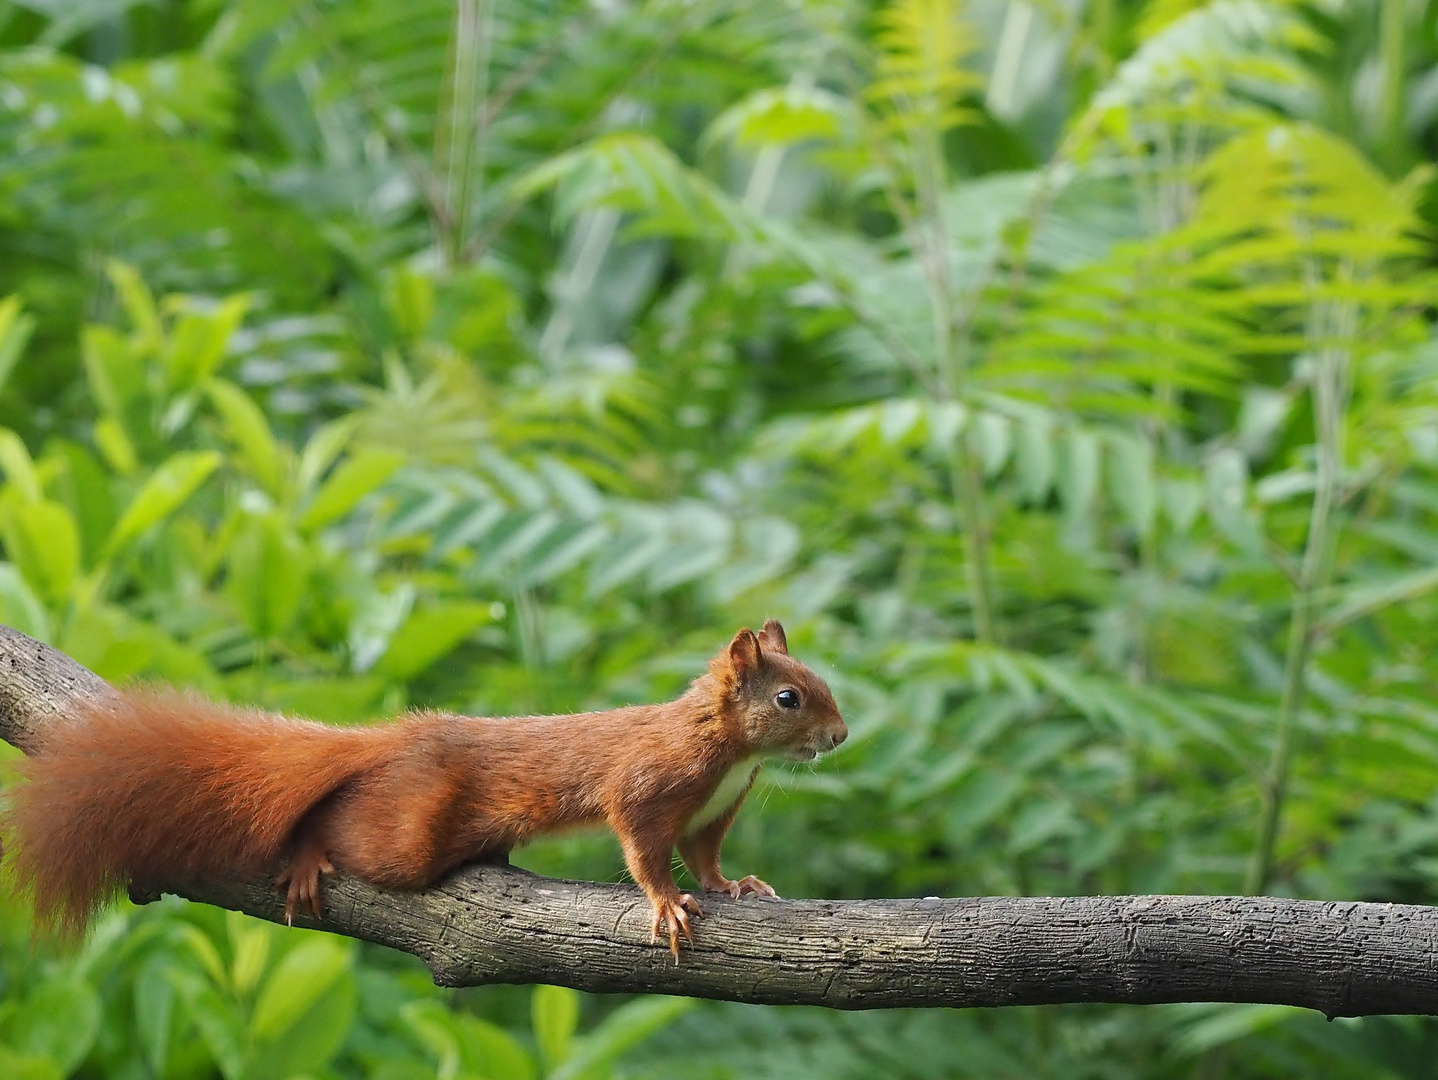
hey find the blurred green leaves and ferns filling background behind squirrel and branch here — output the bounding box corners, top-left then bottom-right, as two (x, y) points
(0, 0), (1438, 1080)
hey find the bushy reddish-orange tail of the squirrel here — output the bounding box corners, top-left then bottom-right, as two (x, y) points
(0, 692), (401, 935)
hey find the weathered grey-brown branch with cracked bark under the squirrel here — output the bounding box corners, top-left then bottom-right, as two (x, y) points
(0, 627), (1438, 1017)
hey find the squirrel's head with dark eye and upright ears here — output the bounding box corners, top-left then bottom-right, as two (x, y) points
(709, 618), (848, 761)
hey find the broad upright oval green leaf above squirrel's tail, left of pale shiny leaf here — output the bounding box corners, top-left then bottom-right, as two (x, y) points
(224, 511), (309, 641)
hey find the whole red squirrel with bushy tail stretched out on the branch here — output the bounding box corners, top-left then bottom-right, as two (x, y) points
(0, 620), (848, 958)
